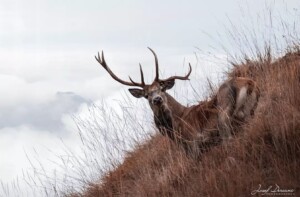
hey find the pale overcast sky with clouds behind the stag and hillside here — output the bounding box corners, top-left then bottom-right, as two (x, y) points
(0, 0), (300, 194)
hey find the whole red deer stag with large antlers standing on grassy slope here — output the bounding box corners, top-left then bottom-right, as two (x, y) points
(95, 48), (259, 154)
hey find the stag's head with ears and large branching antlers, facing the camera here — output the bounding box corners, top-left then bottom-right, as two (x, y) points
(95, 47), (192, 112)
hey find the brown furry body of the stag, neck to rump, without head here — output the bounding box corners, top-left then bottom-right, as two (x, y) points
(150, 77), (259, 153)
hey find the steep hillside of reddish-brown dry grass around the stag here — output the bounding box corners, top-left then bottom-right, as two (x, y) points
(74, 49), (300, 197)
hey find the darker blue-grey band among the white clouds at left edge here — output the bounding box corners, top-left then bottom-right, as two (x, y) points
(0, 92), (90, 132)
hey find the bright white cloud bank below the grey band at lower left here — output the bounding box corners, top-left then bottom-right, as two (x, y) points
(0, 125), (79, 183)
